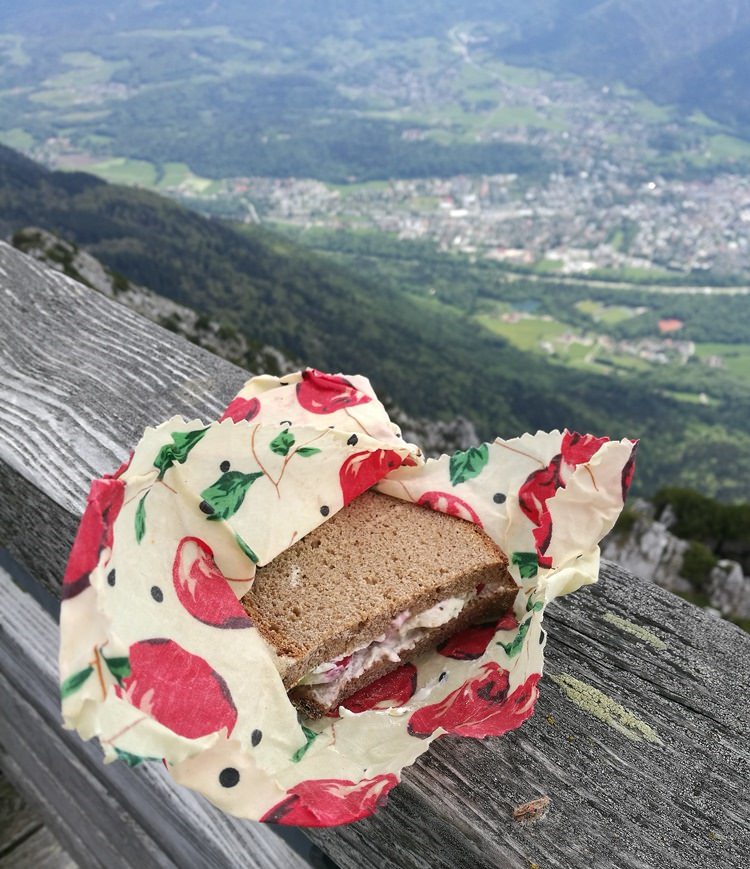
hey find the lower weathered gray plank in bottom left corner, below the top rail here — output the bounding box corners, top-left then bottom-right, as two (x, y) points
(0, 569), (308, 869)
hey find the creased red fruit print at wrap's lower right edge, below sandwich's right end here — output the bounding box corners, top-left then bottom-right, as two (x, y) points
(408, 661), (540, 739)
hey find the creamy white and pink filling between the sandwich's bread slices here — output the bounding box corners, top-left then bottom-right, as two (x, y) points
(297, 583), (503, 705)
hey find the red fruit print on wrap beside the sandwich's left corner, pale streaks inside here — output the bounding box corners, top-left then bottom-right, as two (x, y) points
(172, 537), (252, 628)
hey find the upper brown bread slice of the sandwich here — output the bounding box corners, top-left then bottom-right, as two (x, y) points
(242, 492), (516, 690)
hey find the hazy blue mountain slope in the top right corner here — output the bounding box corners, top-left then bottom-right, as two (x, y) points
(496, 0), (750, 134)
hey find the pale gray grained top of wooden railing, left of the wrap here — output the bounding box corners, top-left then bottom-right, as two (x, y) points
(0, 242), (249, 588)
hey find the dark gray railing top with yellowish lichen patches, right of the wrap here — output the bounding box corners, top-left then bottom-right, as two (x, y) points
(314, 564), (750, 869)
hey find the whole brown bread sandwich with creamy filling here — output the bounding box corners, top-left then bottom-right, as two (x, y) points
(242, 491), (518, 718)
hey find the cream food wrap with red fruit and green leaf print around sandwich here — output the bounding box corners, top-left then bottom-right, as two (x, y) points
(60, 369), (635, 826)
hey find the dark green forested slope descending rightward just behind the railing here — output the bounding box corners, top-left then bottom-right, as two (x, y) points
(0, 148), (750, 498)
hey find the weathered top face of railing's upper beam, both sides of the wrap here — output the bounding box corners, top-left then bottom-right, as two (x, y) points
(0, 247), (750, 869)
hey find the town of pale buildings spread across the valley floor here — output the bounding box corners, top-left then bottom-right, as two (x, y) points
(235, 173), (750, 274)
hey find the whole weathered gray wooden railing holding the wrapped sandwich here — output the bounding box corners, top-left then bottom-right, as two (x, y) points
(0, 244), (750, 869)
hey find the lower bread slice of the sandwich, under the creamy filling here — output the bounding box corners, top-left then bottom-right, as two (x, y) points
(289, 587), (518, 718)
